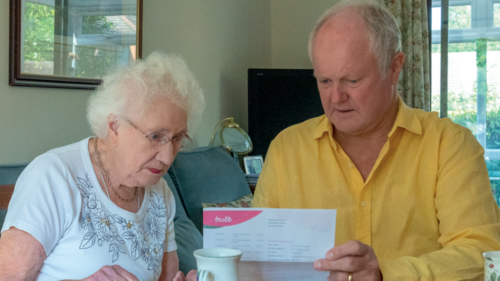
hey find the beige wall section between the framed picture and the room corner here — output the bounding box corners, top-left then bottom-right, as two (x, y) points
(144, 0), (271, 145)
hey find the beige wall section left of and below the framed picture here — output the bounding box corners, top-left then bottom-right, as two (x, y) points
(0, 1), (91, 164)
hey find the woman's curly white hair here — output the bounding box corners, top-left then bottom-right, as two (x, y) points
(87, 52), (205, 138)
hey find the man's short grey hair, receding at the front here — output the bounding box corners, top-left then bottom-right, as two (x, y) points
(308, 0), (402, 77)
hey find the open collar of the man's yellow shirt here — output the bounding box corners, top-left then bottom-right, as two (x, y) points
(313, 96), (422, 142)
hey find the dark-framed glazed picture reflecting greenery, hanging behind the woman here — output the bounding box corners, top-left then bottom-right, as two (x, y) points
(9, 0), (143, 90)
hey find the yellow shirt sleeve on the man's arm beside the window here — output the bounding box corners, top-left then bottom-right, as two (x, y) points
(379, 130), (500, 281)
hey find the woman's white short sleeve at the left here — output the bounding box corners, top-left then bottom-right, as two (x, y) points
(2, 154), (77, 255)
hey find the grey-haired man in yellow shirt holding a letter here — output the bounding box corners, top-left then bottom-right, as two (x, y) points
(252, 3), (500, 281)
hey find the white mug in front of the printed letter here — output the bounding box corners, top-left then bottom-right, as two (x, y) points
(194, 248), (242, 281)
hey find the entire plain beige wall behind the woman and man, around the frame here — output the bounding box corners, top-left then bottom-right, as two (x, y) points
(0, 0), (335, 164)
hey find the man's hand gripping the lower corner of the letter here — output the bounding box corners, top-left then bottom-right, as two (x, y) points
(314, 241), (382, 281)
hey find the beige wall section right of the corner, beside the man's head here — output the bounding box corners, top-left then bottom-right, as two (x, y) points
(271, 0), (338, 68)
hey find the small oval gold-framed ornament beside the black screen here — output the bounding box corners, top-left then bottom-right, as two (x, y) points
(210, 117), (253, 160)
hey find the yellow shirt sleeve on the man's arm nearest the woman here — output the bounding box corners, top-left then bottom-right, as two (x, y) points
(252, 136), (283, 208)
